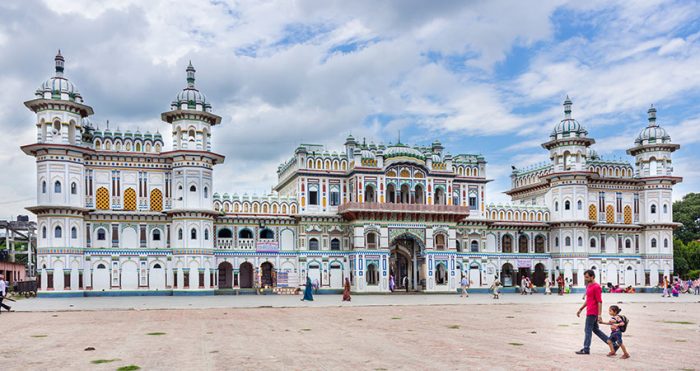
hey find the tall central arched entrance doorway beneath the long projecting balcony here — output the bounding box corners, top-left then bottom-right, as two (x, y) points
(389, 233), (426, 291)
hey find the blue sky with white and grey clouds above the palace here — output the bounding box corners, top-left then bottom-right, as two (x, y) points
(0, 0), (700, 218)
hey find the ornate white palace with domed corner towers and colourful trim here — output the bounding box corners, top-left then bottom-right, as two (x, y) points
(22, 52), (681, 295)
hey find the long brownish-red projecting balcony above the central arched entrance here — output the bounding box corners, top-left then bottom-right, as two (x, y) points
(338, 202), (469, 220)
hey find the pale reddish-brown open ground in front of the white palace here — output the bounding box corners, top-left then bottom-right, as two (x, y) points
(0, 303), (700, 370)
